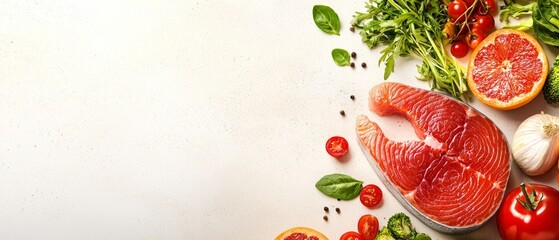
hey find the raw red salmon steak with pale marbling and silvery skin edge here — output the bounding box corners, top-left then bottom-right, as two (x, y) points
(356, 82), (512, 234)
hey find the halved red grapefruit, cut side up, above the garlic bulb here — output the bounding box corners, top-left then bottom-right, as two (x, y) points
(468, 29), (549, 110)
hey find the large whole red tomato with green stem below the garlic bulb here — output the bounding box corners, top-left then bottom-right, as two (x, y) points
(497, 184), (559, 240)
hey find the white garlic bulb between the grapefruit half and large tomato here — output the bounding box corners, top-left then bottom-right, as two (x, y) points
(511, 112), (559, 176)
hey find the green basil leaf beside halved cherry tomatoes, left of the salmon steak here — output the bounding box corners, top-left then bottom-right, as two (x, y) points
(315, 173), (363, 200)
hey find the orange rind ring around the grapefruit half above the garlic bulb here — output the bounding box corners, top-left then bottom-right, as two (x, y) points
(467, 29), (549, 110)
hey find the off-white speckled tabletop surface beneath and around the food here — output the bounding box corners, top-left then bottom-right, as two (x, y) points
(0, 0), (559, 239)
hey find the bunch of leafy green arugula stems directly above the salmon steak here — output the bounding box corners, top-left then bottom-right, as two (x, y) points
(352, 0), (469, 99)
